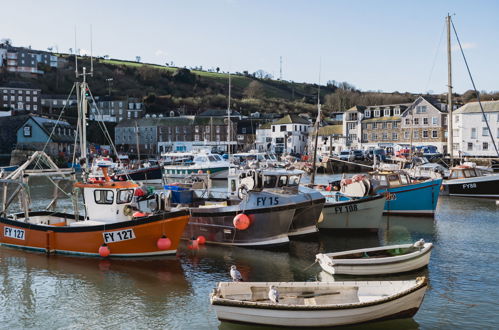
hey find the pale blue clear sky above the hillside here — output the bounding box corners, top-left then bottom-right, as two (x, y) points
(0, 0), (499, 93)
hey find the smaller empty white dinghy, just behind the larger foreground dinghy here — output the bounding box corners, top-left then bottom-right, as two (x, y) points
(315, 239), (433, 275)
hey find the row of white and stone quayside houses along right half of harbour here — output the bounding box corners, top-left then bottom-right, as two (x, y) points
(256, 96), (499, 157)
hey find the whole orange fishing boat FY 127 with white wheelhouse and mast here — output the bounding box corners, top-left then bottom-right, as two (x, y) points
(0, 68), (189, 257)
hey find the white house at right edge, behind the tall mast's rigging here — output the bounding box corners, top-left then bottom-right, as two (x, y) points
(452, 101), (499, 157)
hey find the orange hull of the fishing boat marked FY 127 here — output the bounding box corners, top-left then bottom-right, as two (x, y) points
(0, 212), (189, 257)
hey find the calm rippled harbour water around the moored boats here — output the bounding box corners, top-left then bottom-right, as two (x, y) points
(0, 177), (499, 329)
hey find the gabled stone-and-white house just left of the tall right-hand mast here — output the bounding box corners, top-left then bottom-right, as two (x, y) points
(399, 96), (447, 153)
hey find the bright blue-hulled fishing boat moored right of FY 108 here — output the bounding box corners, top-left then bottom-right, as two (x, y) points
(371, 171), (442, 216)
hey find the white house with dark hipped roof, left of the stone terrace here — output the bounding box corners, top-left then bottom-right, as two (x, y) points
(270, 115), (311, 154)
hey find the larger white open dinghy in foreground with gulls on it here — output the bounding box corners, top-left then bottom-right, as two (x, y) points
(211, 277), (427, 327)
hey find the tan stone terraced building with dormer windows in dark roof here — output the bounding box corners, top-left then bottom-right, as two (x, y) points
(361, 103), (410, 149)
